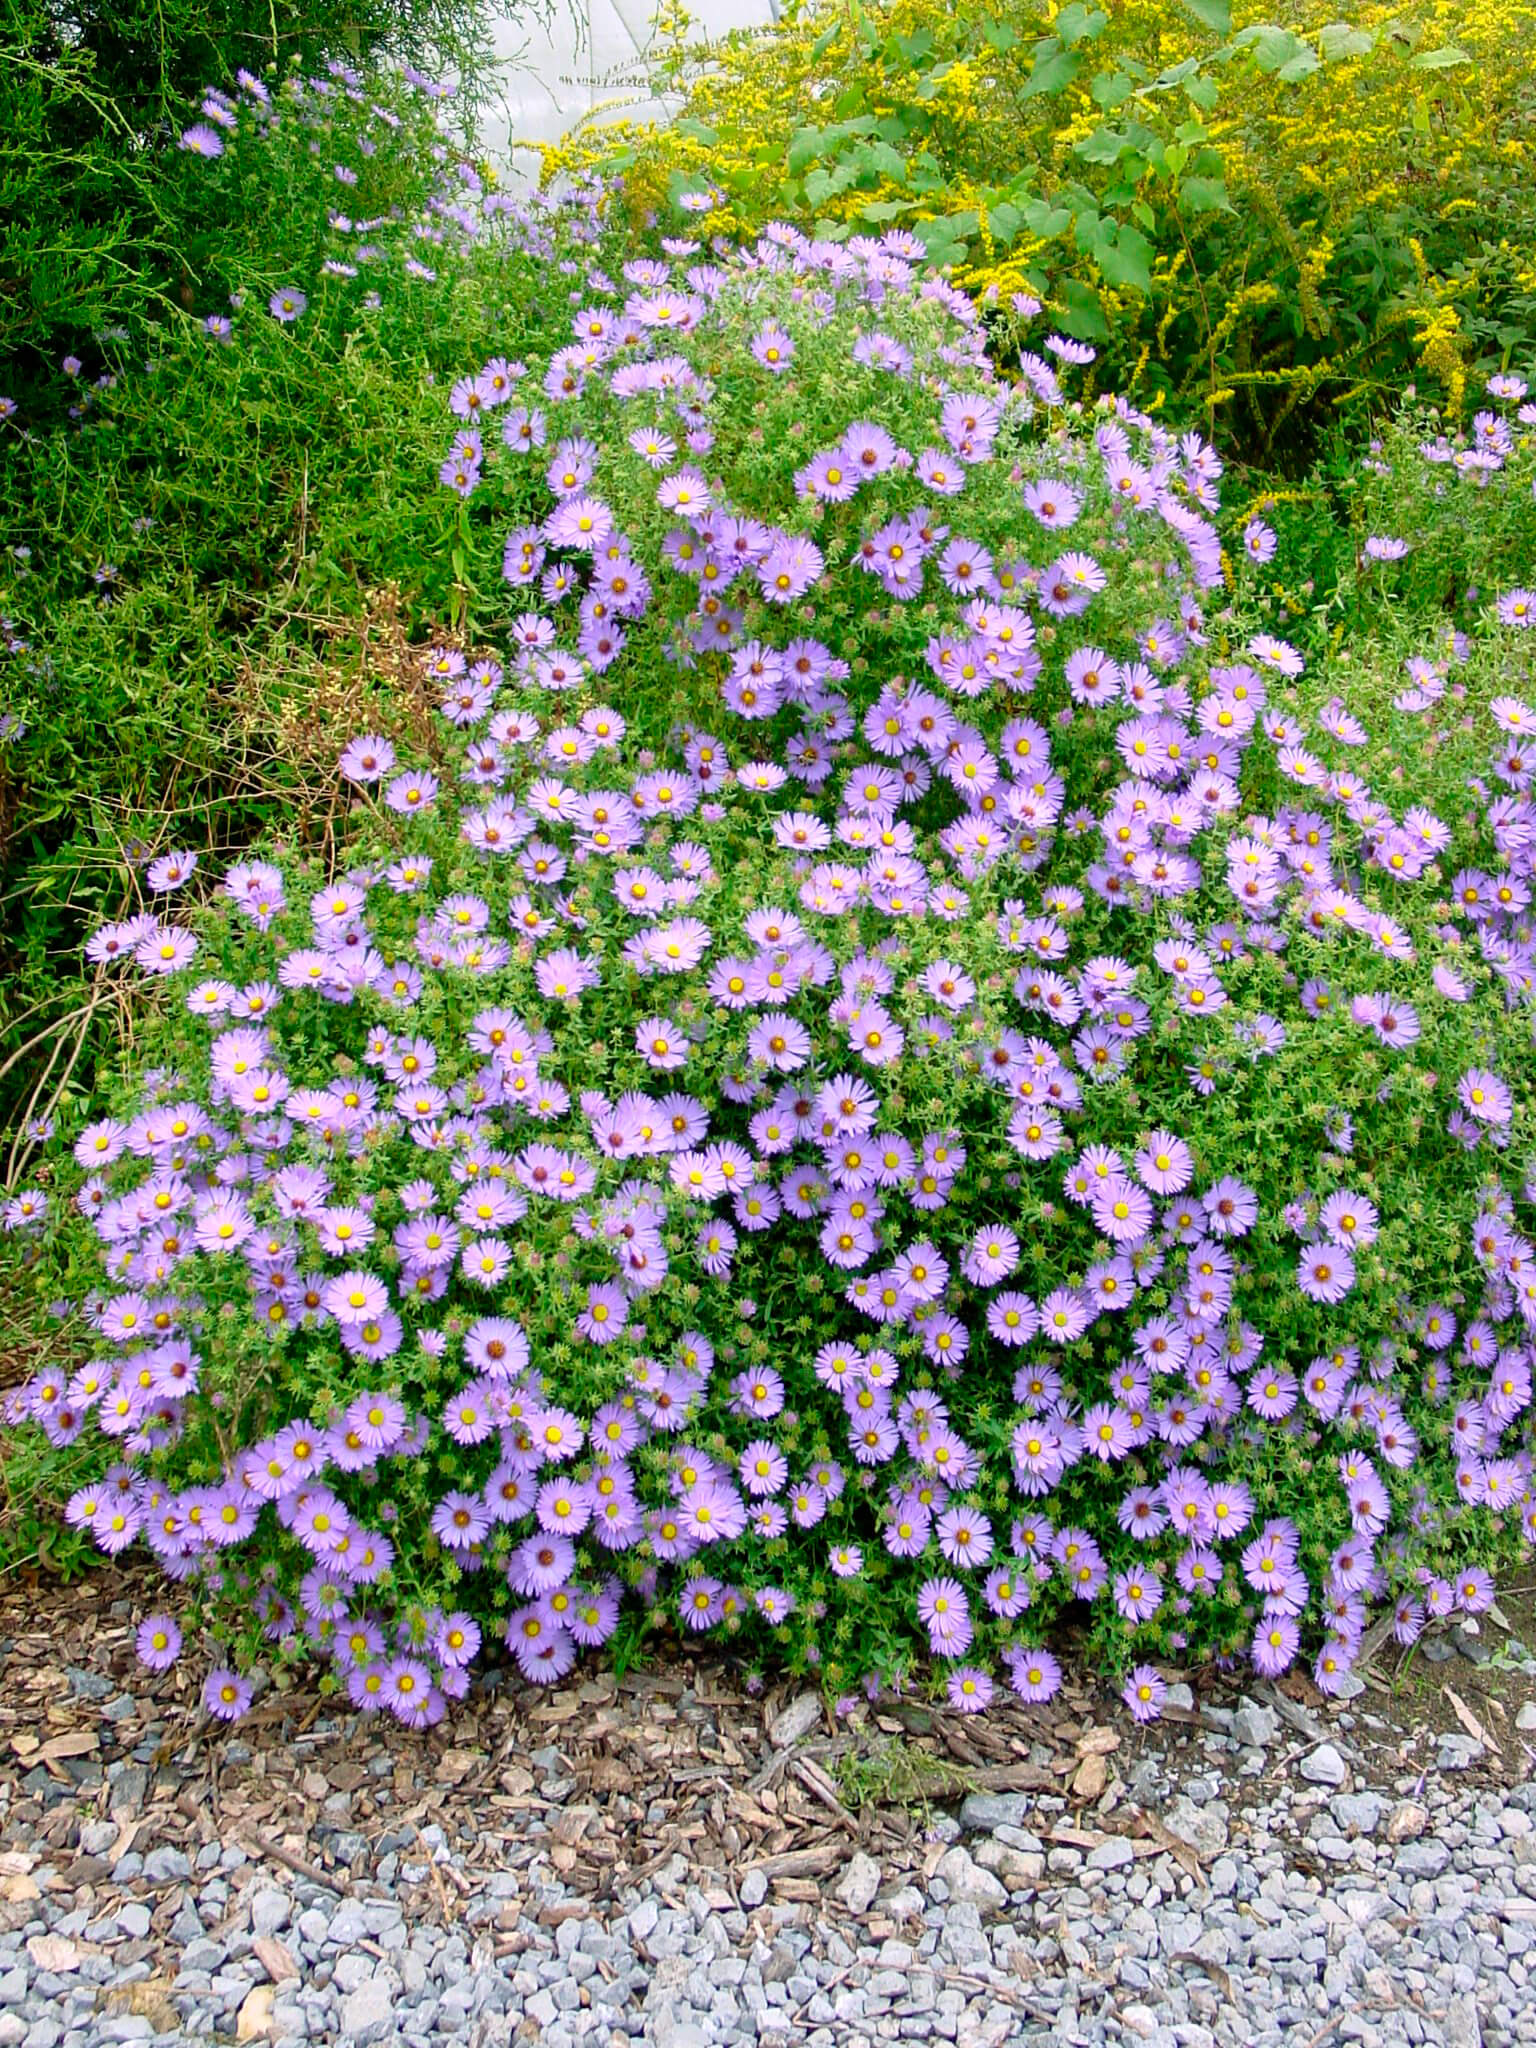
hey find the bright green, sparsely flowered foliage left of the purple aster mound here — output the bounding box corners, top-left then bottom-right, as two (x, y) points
(0, 74), (626, 1124)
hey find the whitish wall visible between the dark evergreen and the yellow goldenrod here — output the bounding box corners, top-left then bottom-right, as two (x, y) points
(485, 0), (778, 170)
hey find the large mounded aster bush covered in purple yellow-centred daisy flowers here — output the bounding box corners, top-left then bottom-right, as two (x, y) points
(6, 199), (1536, 1722)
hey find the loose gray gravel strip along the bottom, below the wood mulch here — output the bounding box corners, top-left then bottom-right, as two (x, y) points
(0, 1702), (1536, 2048)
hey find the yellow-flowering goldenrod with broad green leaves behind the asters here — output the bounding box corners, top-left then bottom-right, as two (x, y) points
(545, 0), (1536, 459)
